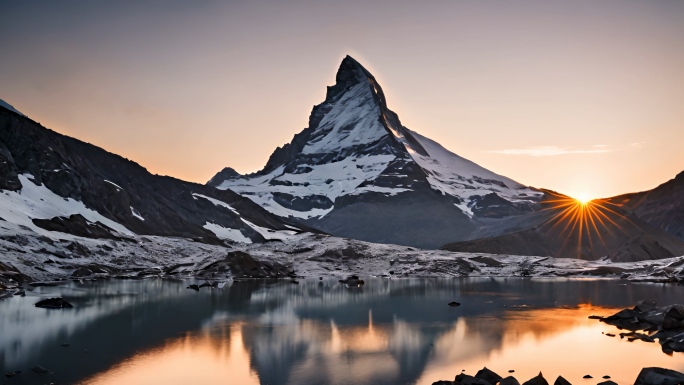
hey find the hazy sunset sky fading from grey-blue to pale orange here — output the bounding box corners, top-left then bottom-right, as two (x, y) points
(0, 0), (684, 201)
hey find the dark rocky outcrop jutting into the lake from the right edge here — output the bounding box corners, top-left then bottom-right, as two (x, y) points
(593, 300), (684, 353)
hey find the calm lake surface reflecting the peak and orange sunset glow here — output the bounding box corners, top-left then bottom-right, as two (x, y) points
(0, 278), (684, 385)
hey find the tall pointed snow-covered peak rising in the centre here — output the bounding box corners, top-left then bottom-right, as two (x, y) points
(209, 56), (544, 248)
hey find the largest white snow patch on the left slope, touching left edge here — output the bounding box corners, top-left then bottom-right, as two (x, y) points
(0, 174), (134, 234)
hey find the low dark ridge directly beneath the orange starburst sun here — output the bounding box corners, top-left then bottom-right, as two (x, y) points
(442, 192), (684, 262)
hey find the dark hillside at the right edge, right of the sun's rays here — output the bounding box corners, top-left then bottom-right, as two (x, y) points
(608, 171), (684, 240)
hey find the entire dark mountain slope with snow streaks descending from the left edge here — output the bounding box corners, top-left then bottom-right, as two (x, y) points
(0, 103), (308, 243)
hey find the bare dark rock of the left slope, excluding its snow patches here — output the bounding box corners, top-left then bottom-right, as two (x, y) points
(0, 107), (312, 244)
